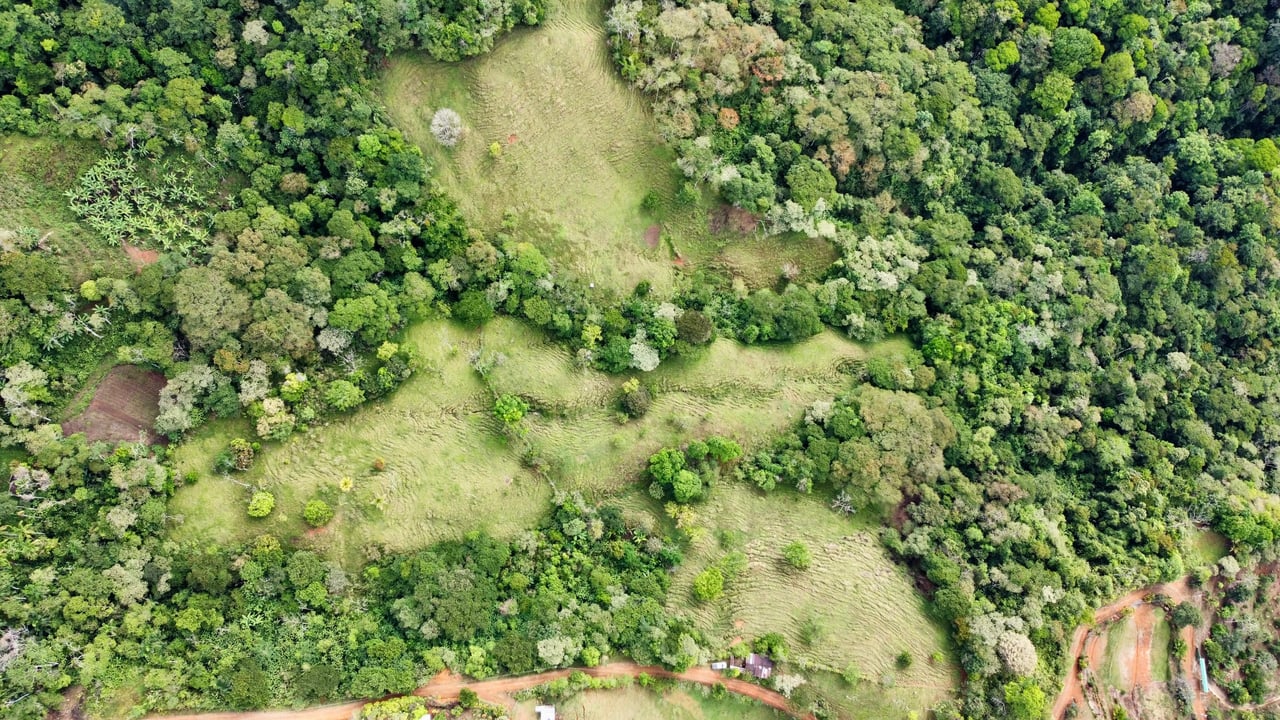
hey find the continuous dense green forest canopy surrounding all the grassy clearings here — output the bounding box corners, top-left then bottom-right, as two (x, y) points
(0, 0), (1280, 717)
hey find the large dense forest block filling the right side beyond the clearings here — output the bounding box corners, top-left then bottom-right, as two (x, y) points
(611, 1), (1280, 716)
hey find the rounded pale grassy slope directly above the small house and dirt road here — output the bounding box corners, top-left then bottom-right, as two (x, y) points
(668, 482), (959, 717)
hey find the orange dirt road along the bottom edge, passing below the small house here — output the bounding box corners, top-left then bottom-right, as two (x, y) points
(150, 662), (814, 720)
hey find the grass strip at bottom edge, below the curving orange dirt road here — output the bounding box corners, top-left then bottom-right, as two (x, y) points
(511, 687), (786, 720)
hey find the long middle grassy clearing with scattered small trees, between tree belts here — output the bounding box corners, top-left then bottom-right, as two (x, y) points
(173, 319), (885, 564)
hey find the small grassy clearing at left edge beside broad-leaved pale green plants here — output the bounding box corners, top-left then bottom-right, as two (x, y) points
(0, 135), (131, 282)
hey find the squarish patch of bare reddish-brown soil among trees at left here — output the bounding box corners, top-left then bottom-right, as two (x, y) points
(63, 365), (169, 445)
